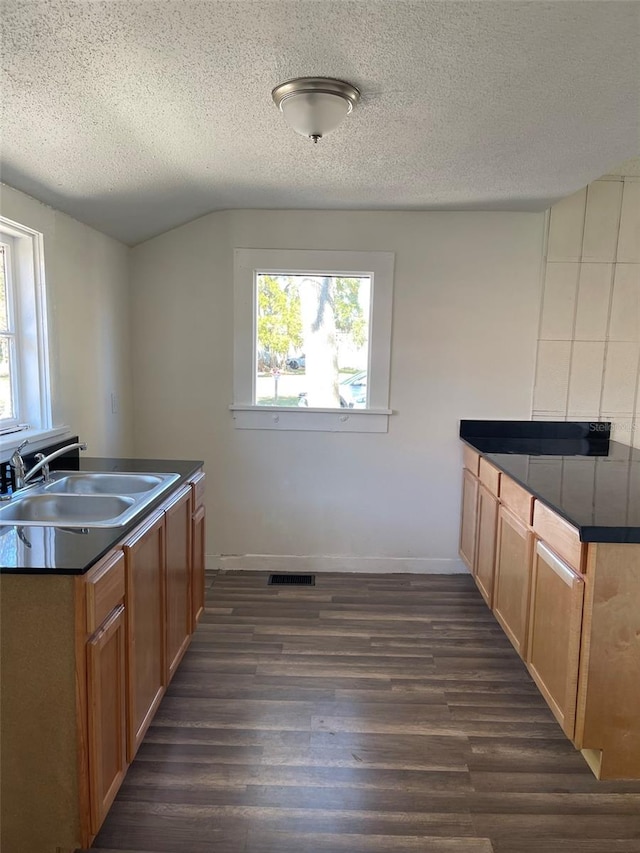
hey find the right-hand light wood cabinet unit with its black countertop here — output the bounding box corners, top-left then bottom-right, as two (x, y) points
(460, 421), (640, 779)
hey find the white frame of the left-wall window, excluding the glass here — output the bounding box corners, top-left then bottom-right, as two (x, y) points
(0, 216), (52, 440)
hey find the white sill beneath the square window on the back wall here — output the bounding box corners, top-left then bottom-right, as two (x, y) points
(229, 405), (393, 432)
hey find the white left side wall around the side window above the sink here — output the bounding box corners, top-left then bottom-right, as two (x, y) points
(0, 185), (133, 456)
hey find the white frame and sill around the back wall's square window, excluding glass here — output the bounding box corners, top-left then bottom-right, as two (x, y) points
(229, 248), (395, 432)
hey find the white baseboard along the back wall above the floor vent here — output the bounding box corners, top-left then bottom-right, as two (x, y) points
(207, 554), (469, 575)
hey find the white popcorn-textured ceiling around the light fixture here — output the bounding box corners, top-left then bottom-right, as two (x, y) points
(1, 0), (640, 244)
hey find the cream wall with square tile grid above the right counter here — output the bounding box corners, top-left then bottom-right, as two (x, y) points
(533, 159), (640, 447)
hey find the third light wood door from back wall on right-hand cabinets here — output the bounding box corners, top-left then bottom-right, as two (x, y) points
(493, 506), (533, 657)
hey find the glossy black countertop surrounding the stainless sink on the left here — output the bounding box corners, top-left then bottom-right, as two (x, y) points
(0, 456), (203, 575)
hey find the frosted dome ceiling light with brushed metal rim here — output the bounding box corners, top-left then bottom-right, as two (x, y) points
(271, 77), (360, 142)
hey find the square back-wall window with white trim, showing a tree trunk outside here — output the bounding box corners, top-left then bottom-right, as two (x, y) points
(231, 249), (394, 432)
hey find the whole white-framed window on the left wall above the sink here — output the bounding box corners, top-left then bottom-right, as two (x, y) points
(0, 217), (51, 440)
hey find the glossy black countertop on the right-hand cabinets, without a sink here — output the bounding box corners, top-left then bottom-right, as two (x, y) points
(460, 422), (640, 543)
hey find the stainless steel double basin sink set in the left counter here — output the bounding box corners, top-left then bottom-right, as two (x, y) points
(0, 471), (180, 527)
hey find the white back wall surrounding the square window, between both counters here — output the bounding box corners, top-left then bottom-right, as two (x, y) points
(132, 211), (544, 571)
